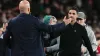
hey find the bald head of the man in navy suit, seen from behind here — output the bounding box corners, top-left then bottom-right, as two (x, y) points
(19, 0), (30, 14)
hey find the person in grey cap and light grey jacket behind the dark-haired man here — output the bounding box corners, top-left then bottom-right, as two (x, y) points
(77, 12), (98, 56)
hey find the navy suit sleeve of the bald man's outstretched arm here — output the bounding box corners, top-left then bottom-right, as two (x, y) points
(35, 18), (66, 37)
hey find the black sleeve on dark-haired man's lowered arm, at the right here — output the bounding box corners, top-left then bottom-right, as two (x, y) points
(82, 27), (94, 56)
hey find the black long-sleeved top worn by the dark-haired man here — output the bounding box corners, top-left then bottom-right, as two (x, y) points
(60, 23), (93, 56)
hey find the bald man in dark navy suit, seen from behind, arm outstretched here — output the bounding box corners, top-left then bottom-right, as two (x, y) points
(4, 0), (69, 56)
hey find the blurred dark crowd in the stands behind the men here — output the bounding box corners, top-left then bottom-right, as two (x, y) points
(0, 0), (100, 48)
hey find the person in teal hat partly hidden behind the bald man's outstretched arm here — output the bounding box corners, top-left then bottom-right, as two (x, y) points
(43, 15), (59, 56)
